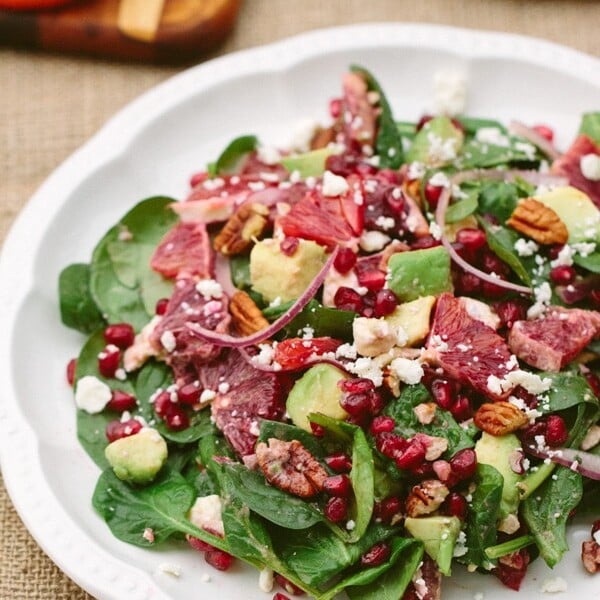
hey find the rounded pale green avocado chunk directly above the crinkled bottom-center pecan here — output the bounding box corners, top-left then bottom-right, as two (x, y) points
(286, 363), (348, 431)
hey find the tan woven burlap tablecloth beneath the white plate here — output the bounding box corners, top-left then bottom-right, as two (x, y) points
(0, 0), (600, 600)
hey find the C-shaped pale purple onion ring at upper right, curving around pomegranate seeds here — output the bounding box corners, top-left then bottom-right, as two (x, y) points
(435, 169), (565, 295)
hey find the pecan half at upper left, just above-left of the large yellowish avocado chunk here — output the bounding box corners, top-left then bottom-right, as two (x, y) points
(213, 202), (269, 256)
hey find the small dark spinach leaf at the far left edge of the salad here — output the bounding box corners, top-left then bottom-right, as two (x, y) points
(58, 263), (104, 333)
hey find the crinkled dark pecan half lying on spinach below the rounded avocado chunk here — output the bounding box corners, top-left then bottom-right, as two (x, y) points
(256, 438), (328, 498)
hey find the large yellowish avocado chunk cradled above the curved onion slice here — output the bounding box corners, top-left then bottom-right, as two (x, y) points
(250, 238), (326, 302)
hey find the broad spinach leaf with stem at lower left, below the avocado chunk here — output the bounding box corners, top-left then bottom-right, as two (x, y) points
(92, 469), (228, 550)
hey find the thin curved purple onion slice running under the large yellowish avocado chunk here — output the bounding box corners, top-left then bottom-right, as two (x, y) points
(186, 248), (338, 348)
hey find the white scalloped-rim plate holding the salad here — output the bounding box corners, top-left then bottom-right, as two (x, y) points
(0, 24), (600, 600)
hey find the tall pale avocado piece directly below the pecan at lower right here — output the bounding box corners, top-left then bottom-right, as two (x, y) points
(475, 431), (523, 520)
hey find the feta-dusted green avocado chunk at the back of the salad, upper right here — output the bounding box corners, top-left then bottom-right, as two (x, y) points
(406, 116), (465, 167)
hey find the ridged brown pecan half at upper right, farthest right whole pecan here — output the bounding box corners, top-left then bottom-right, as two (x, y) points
(506, 198), (569, 245)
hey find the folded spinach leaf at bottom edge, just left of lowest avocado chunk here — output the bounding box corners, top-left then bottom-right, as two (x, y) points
(342, 538), (423, 600)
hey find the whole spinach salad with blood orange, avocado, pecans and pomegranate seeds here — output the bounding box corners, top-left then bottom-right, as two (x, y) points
(59, 66), (600, 600)
